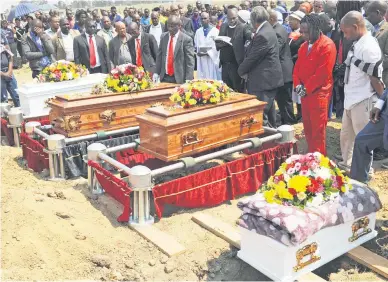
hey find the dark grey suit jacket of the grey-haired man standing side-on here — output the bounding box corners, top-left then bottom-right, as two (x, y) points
(238, 22), (284, 94)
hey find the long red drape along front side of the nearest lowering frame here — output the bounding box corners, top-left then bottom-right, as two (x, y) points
(153, 143), (293, 218)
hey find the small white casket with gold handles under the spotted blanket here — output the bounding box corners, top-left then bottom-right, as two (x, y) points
(237, 213), (377, 281)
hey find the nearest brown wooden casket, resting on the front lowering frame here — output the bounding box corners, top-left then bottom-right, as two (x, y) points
(136, 94), (266, 161)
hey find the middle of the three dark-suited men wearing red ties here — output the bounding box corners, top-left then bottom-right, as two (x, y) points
(128, 22), (158, 73)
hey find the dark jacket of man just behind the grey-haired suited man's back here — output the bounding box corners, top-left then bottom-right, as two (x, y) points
(273, 23), (294, 83)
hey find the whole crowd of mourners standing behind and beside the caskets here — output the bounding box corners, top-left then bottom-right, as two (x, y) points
(1, 0), (388, 182)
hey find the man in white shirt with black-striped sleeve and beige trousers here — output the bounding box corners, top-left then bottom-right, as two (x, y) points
(339, 11), (383, 170)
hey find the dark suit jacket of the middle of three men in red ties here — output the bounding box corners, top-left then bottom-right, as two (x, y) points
(128, 32), (158, 73)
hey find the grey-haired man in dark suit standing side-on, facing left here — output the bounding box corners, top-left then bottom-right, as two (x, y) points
(238, 7), (284, 127)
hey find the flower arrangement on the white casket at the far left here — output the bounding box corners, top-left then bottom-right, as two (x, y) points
(37, 60), (89, 82)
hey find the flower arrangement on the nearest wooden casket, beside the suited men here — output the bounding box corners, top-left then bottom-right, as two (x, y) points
(170, 79), (232, 108)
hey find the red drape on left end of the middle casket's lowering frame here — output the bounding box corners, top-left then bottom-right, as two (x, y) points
(20, 132), (49, 172)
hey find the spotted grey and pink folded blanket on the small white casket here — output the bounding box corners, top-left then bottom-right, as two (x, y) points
(237, 181), (382, 246)
